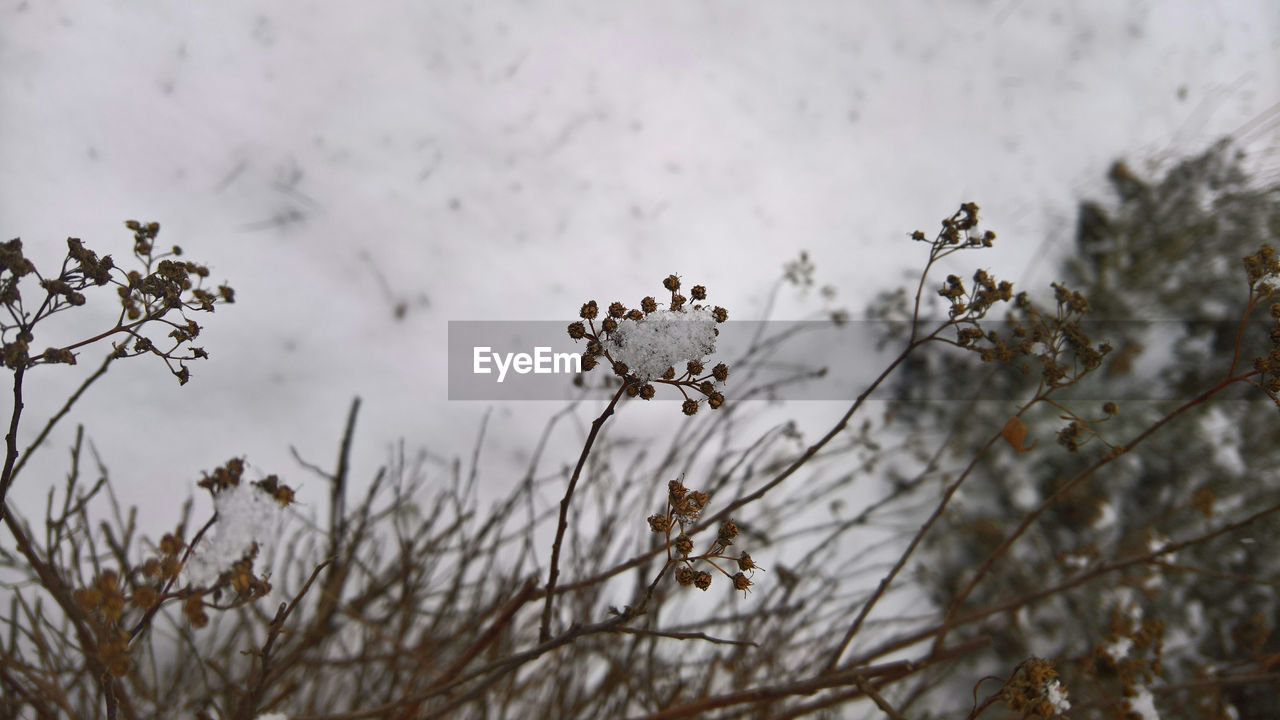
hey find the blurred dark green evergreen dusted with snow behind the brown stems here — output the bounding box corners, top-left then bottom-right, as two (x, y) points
(893, 141), (1280, 717)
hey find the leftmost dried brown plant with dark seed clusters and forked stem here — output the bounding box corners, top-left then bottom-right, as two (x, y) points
(0, 220), (292, 717)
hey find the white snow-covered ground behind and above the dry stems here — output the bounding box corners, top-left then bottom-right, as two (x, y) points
(0, 0), (1280, 538)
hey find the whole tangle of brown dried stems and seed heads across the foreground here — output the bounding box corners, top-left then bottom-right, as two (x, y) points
(0, 147), (1280, 720)
